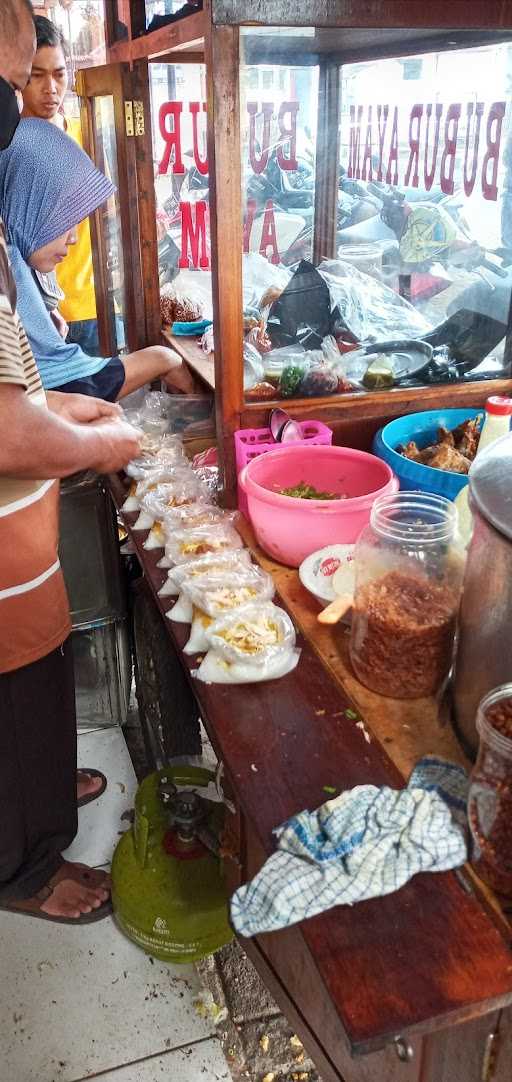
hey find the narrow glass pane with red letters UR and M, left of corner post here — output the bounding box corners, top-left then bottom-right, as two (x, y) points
(149, 64), (212, 326)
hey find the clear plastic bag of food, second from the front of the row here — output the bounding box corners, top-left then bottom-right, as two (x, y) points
(179, 564), (275, 654)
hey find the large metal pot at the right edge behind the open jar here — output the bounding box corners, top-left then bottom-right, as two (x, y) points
(454, 435), (512, 756)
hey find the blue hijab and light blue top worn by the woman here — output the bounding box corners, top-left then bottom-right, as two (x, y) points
(0, 119), (115, 388)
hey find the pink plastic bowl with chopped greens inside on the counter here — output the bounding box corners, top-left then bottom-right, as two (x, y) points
(239, 445), (398, 567)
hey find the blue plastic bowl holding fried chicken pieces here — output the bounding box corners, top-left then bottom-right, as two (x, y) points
(372, 409), (483, 500)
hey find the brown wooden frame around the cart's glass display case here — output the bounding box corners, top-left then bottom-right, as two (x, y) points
(93, 0), (512, 495)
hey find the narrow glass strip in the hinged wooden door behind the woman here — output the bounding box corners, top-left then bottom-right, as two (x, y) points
(93, 95), (127, 353)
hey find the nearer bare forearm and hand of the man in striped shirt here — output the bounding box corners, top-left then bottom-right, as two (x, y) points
(0, 383), (140, 480)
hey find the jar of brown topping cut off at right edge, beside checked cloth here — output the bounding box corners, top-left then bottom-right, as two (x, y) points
(468, 684), (512, 898)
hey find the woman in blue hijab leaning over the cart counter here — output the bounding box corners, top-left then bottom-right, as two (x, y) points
(0, 119), (194, 401)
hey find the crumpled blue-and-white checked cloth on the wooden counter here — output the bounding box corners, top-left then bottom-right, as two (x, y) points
(231, 756), (468, 936)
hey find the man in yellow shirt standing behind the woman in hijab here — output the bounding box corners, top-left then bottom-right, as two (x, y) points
(22, 15), (100, 356)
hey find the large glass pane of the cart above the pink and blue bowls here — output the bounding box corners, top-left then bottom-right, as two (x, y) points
(240, 27), (512, 400)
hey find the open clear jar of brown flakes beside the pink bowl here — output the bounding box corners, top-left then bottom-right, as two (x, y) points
(350, 492), (464, 699)
